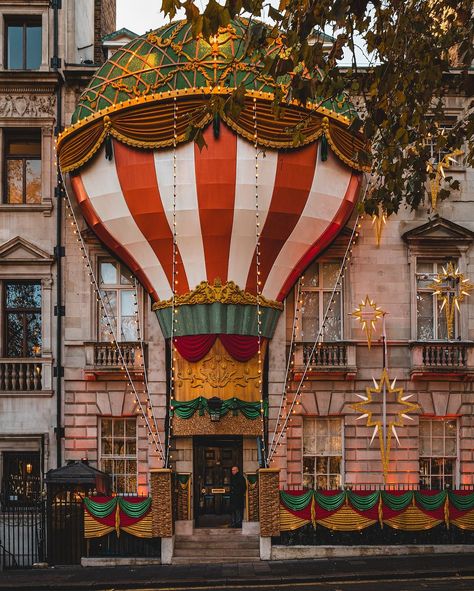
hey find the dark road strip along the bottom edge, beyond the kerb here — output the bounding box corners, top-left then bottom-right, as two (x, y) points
(125, 576), (474, 591)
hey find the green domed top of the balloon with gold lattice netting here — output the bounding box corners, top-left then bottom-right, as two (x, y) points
(72, 18), (355, 123)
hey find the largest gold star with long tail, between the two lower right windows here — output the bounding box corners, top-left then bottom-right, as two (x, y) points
(351, 368), (419, 480)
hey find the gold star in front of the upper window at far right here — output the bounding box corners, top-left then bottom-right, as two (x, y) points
(428, 263), (474, 339)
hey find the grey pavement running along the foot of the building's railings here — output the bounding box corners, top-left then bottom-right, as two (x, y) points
(0, 553), (474, 591)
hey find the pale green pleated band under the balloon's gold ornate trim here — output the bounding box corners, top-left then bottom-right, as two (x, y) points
(156, 302), (281, 339)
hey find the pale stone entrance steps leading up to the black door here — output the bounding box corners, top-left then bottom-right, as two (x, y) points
(173, 528), (260, 564)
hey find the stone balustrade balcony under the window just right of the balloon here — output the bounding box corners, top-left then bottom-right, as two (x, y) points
(294, 341), (357, 380)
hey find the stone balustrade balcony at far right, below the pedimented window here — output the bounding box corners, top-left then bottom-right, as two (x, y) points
(410, 341), (474, 381)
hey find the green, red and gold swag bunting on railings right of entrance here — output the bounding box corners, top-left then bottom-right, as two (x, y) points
(280, 490), (474, 531)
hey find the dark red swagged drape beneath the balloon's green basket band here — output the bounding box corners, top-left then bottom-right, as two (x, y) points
(174, 334), (263, 362)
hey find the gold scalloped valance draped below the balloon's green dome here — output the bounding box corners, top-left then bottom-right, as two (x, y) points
(57, 88), (367, 172)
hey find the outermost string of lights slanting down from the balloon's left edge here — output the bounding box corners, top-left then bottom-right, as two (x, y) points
(60, 178), (165, 462)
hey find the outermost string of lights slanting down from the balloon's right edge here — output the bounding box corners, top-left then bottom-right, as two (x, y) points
(267, 178), (370, 463)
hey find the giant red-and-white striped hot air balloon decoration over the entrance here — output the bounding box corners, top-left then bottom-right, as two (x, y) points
(58, 19), (366, 444)
